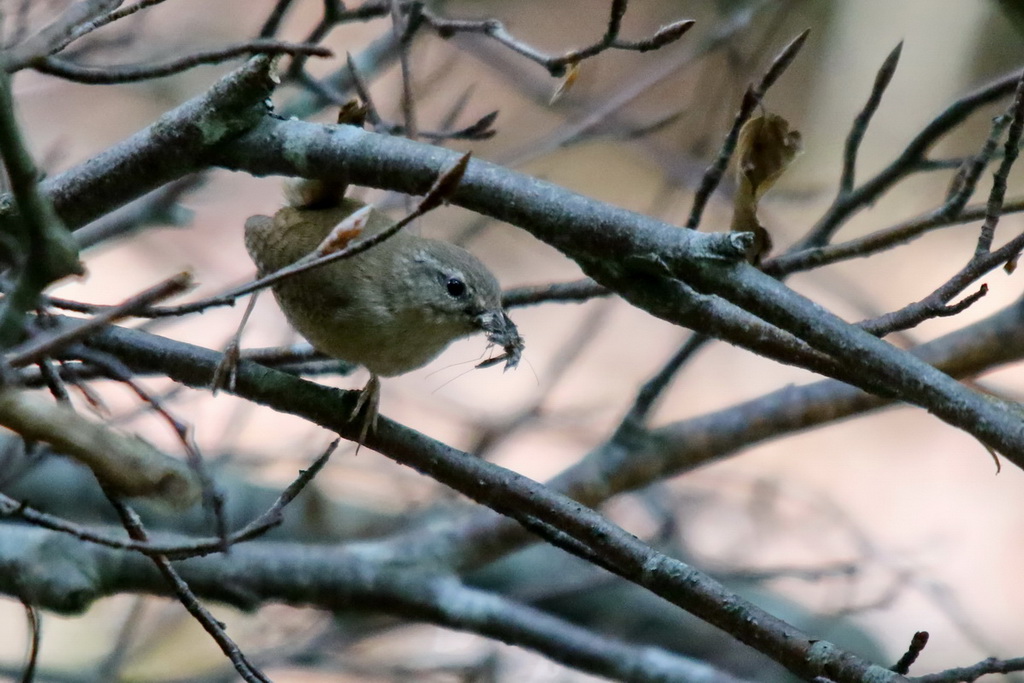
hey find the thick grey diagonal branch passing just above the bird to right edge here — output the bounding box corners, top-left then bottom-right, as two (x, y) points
(211, 119), (1024, 467)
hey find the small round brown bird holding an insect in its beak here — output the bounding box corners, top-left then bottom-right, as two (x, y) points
(245, 181), (523, 441)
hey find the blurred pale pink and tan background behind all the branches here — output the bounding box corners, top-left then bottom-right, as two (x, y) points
(0, 0), (1024, 681)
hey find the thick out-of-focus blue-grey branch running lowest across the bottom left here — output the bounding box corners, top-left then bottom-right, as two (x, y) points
(0, 524), (753, 683)
